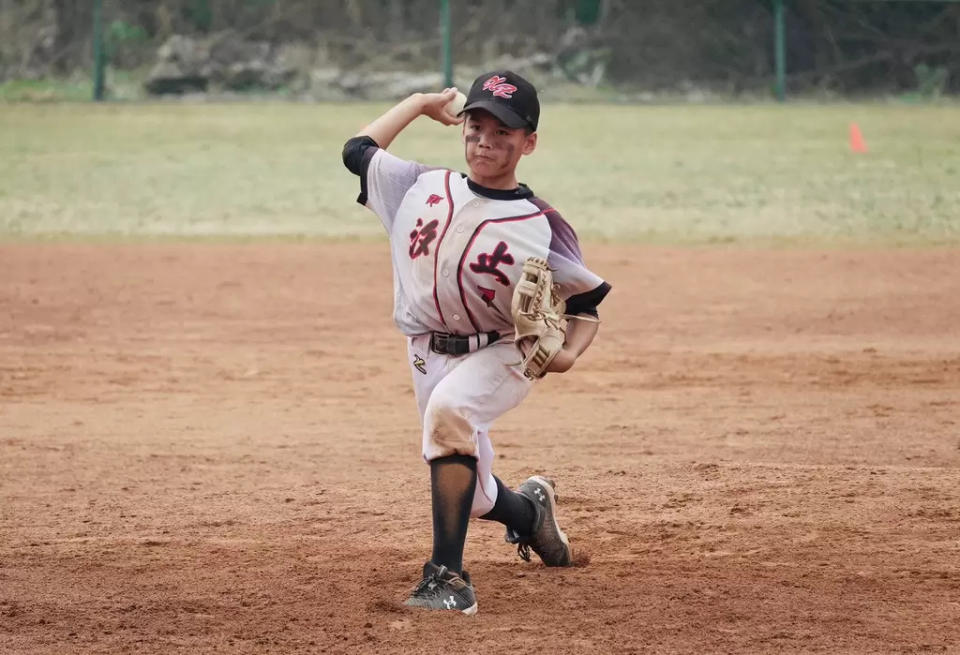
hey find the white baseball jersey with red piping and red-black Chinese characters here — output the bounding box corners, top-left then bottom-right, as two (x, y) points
(358, 141), (610, 336)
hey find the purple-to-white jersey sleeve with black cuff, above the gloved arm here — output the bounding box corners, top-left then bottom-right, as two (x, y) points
(545, 209), (612, 316)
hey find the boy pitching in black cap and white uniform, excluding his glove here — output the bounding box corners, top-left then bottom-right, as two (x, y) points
(343, 71), (610, 614)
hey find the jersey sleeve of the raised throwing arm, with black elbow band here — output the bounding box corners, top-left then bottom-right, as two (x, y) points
(343, 136), (430, 233)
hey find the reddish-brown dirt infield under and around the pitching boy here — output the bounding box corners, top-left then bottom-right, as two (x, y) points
(0, 243), (960, 654)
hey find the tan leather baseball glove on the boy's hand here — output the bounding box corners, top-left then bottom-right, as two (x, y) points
(510, 257), (567, 379)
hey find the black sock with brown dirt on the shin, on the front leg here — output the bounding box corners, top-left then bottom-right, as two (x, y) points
(430, 455), (477, 574)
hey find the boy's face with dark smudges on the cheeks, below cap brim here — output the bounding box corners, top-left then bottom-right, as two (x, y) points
(463, 110), (537, 179)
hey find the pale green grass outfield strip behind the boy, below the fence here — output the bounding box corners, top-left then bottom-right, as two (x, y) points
(0, 103), (960, 245)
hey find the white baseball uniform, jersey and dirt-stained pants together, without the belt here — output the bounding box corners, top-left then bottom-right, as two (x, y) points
(344, 137), (610, 516)
